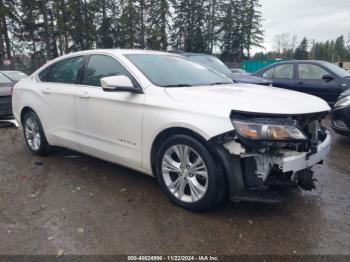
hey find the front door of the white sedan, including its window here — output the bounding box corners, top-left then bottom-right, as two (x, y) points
(76, 54), (144, 168)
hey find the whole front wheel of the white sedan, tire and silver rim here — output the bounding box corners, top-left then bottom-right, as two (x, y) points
(156, 135), (226, 212)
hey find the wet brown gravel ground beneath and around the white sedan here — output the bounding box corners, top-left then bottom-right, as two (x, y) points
(0, 121), (350, 255)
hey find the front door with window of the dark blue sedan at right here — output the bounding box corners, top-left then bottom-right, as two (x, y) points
(296, 63), (339, 103)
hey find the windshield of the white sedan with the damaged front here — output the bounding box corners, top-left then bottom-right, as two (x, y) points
(125, 54), (232, 87)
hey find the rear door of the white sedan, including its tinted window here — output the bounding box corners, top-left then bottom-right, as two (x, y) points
(36, 56), (85, 149)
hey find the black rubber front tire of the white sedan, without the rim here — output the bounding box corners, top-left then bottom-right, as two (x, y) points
(156, 135), (220, 212)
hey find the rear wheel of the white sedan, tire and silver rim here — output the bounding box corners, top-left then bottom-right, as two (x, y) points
(23, 111), (51, 156)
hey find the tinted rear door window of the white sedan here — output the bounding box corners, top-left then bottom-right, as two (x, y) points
(39, 56), (84, 84)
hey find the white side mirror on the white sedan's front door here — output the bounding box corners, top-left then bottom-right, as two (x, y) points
(100, 75), (140, 93)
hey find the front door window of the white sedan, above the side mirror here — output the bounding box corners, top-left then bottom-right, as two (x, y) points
(84, 55), (132, 86)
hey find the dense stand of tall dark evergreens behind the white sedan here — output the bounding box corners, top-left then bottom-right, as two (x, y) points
(0, 0), (272, 62)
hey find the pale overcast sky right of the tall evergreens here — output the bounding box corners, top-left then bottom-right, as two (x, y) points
(255, 0), (350, 51)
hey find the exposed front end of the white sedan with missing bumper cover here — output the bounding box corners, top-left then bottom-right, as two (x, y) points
(211, 111), (331, 202)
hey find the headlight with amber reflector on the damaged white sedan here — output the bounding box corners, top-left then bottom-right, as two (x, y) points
(232, 120), (307, 141)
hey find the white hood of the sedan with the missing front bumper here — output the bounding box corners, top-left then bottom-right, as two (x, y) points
(165, 84), (330, 115)
